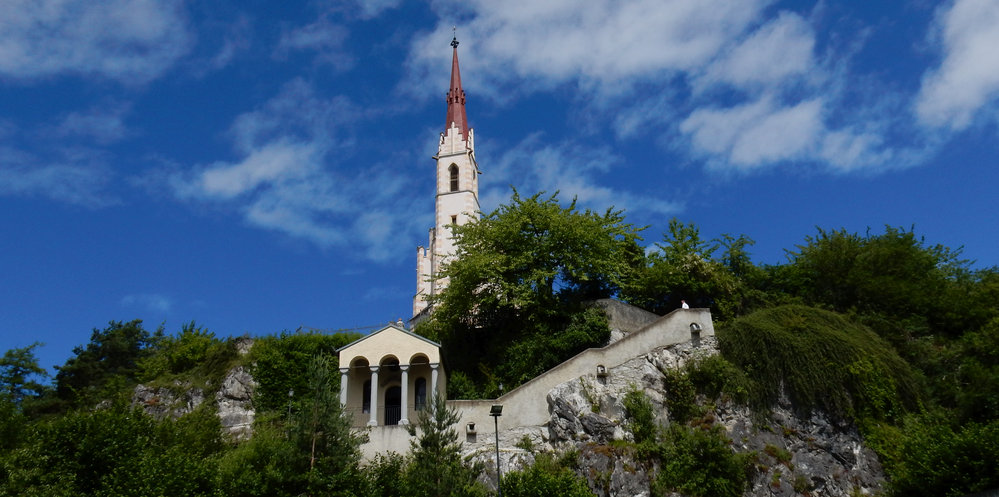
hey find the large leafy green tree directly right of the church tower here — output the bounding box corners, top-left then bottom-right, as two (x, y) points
(420, 191), (641, 394)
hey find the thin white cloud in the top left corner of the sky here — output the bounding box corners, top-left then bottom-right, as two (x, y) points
(0, 0), (192, 83)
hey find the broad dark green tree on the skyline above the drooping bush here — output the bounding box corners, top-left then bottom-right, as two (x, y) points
(784, 226), (984, 338)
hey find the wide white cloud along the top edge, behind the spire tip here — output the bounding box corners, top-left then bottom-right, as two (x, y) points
(410, 0), (771, 100)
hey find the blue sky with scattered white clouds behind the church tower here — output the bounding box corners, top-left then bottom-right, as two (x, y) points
(0, 0), (999, 367)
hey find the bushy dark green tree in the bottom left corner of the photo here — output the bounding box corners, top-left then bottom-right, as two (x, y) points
(0, 402), (222, 497)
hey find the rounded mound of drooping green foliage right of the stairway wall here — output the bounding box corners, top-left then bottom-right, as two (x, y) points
(718, 305), (919, 421)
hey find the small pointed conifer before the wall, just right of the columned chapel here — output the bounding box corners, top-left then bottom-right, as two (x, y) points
(407, 395), (484, 497)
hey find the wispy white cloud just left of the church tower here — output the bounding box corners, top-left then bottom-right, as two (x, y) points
(167, 80), (425, 261)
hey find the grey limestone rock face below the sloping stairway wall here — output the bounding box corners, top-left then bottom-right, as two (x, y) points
(536, 337), (884, 497)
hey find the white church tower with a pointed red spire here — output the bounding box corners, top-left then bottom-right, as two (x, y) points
(413, 37), (480, 322)
